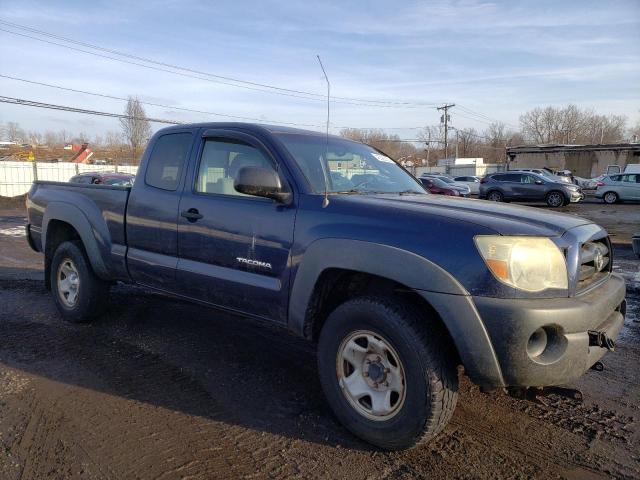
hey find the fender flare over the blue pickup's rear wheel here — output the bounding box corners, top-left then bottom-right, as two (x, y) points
(42, 201), (111, 280)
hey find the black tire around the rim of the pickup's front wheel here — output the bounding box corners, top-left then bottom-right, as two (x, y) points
(318, 297), (458, 450)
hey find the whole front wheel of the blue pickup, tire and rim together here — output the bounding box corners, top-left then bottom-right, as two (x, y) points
(318, 297), (458, 450)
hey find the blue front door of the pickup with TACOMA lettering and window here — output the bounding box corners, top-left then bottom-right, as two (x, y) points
(176, 130), (296, 322)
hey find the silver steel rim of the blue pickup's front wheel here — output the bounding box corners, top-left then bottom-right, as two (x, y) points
(336, 330), (406, 421)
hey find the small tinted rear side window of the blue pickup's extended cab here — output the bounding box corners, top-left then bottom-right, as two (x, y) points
(144, 133), (192, 190)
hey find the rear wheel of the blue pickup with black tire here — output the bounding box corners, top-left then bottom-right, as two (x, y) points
(50, 242), (110, 323)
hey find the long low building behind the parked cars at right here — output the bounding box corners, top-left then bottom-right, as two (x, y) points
(507, 143), (640, 178)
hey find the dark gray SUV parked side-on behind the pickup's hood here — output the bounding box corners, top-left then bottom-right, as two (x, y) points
(480, 172), (584, 208)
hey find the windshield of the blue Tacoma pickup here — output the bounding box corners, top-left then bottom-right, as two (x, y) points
(278, 133), (426, 194)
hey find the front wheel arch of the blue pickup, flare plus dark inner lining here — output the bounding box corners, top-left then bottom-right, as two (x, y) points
(288, 239), (503, 388)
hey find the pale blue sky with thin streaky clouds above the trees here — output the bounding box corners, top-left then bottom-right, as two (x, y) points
(0, 0), (640, 138)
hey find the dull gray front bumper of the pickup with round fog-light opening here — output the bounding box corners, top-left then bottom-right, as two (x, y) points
(473, 274), (626, 387)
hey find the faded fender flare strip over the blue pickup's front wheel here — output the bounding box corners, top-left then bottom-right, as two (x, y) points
(288, 238), (504, 388)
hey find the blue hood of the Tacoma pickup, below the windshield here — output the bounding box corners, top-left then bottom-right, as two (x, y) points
(343, 191), (593, 237)
